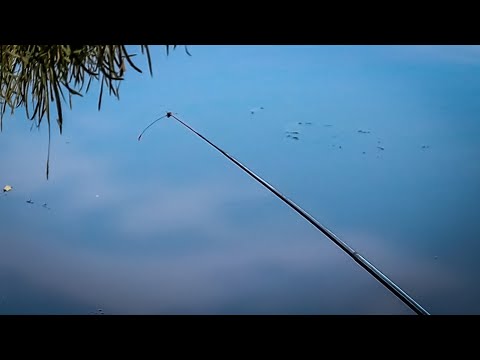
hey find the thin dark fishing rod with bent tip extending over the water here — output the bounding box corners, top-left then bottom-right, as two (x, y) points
(138, 111), (430, 315)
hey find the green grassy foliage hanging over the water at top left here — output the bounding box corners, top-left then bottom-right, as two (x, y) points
(0, 45), (190, 179)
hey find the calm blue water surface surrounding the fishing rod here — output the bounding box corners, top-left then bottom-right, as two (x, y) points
(0, 46), (480, 314)
